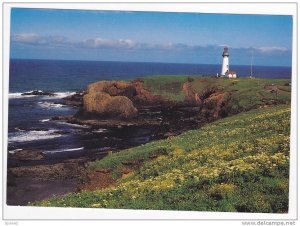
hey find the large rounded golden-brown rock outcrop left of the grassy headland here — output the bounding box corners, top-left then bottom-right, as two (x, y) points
(77, 80), (163, 119)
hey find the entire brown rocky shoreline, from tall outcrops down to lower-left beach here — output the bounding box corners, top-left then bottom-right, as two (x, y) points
(7, 80), (234, 205)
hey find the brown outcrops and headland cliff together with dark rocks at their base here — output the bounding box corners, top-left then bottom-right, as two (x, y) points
(65, 79), (231, 127)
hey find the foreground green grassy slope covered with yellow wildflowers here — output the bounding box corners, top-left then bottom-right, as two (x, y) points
(32, 105), (290, 213)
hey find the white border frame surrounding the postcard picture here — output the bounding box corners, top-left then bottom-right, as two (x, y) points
(2, 2), (298, 220)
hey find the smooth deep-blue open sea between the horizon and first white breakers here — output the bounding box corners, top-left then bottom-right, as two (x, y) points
(9, 59), (291, 93)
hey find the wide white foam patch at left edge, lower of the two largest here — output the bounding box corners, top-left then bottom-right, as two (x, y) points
(8, 130), (62, 143)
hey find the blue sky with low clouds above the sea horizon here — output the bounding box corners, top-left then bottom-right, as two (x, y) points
(10, 8), (293, 66)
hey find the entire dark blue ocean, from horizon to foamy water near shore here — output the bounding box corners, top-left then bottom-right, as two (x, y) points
(8, 59), (291, 162)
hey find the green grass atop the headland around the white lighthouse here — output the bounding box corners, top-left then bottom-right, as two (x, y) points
(142, 75), (291, 115)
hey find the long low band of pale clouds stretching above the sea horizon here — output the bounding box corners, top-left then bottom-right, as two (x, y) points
(11, 33), (290, 56)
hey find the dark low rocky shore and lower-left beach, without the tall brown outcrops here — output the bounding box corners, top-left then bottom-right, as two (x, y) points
(7, 107), (203, 205)
